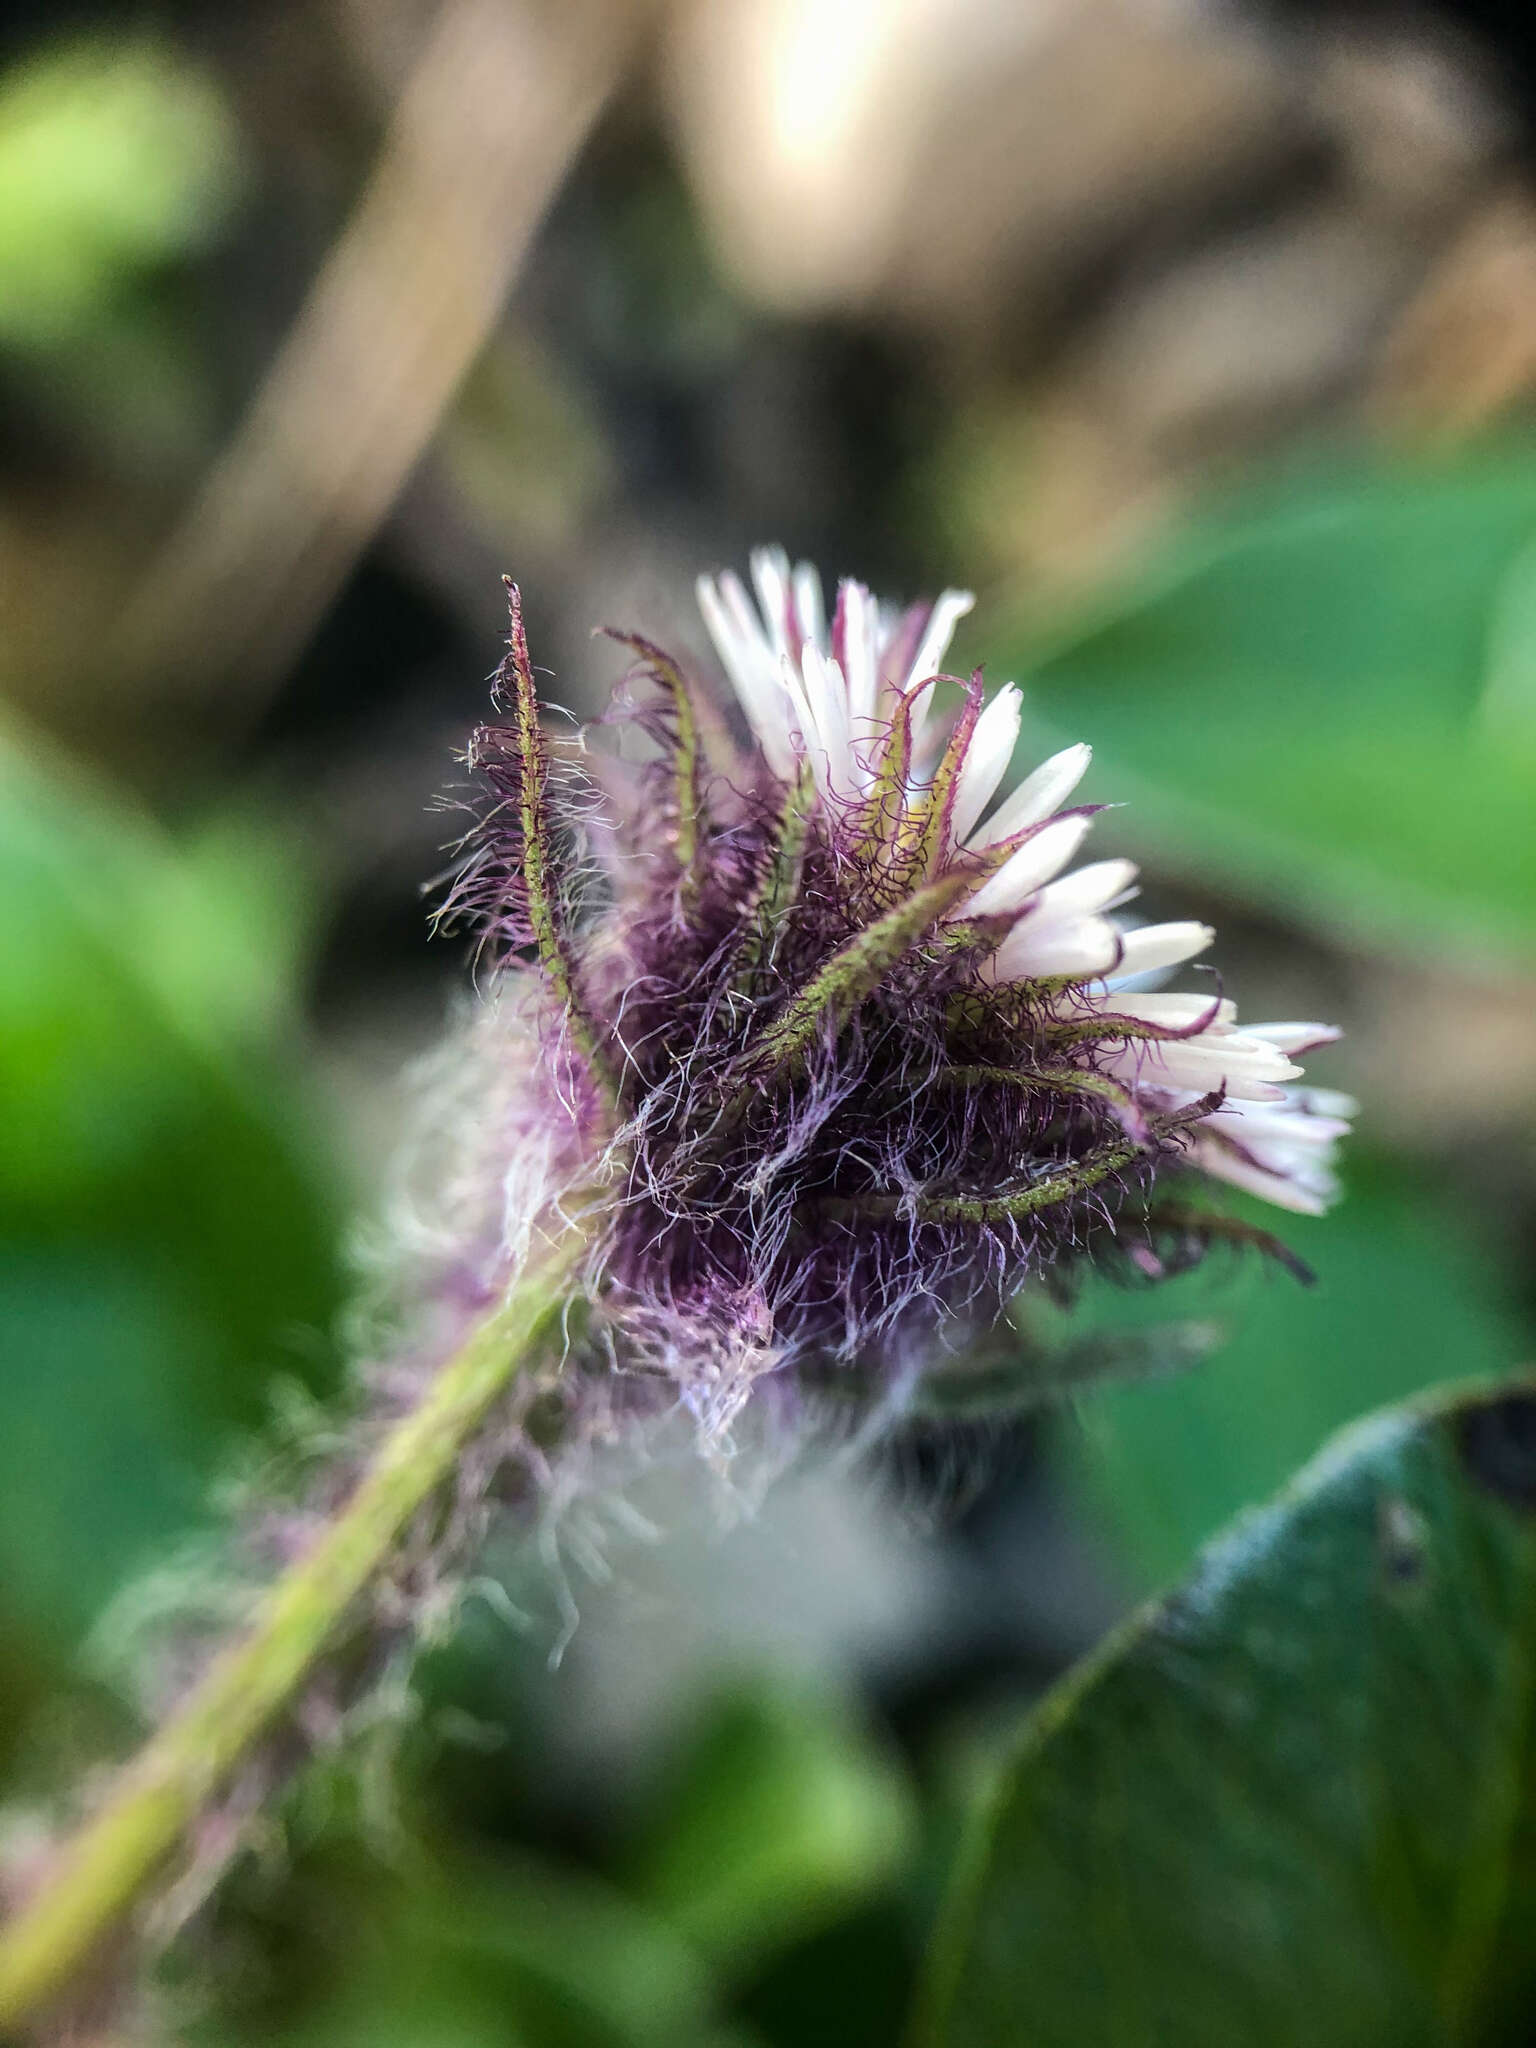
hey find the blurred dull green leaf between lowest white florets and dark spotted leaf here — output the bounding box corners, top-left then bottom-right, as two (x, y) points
(1036, 1149), (1532, 1591)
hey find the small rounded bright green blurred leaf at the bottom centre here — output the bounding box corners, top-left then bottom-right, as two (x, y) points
(631, 1683), (911, 1970)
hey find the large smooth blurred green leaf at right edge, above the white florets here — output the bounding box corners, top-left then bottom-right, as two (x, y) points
(1004, 449), (1536, 952)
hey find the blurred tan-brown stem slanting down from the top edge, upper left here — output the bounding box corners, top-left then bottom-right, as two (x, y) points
(119, 0), (643, 725)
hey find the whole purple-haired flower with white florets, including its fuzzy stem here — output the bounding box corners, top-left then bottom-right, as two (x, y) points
(0, 551), (1350, 2028)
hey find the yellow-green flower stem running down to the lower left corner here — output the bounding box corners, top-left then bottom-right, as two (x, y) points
(0, 1223), (588, 2034)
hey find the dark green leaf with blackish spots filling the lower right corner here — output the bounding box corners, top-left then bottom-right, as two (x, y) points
(915, 1376), (1536, 2048)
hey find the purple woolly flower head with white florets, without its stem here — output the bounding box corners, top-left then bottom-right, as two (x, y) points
(442, 549), (1352, 1423)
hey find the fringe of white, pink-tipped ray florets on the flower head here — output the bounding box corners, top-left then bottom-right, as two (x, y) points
(698, 549), (1354, 1214)
